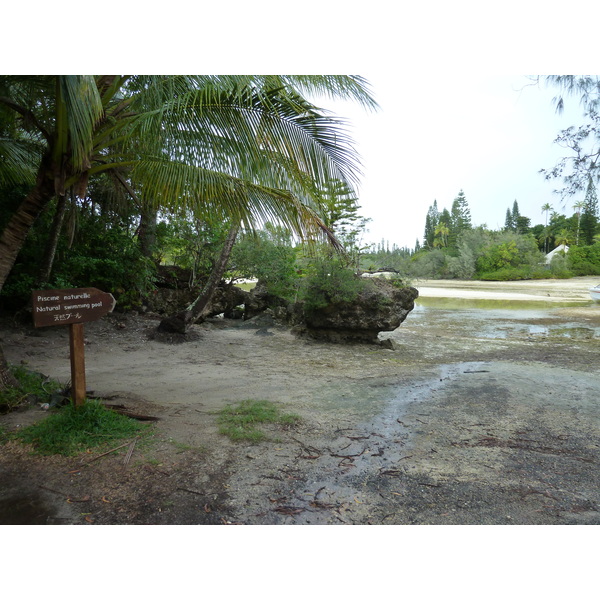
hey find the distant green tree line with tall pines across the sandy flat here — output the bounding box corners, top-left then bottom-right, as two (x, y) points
(363, 181), (600, 280)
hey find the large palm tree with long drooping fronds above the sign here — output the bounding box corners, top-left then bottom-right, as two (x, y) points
(0, 75), (377, 384)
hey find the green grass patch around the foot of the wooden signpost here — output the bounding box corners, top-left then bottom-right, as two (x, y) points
(15, 400), (150, 456)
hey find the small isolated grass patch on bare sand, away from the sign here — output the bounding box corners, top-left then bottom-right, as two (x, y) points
(217, 400), (300, 443)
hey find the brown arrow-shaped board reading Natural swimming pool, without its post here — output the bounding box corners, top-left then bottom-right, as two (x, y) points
(31, 288), (116, 327)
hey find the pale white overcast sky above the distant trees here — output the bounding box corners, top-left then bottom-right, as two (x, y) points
(327, 73), (582, 248)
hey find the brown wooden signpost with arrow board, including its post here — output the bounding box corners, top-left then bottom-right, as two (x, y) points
(31, 288), (116, 406)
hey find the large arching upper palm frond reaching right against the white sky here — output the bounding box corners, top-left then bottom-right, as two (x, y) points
(131, 86), (359, 187)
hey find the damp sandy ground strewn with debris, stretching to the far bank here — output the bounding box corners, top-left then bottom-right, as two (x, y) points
(0, 278), (600, 524)
